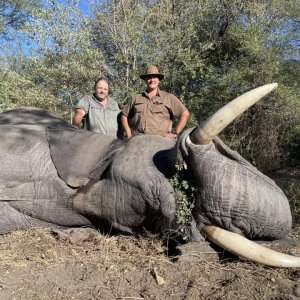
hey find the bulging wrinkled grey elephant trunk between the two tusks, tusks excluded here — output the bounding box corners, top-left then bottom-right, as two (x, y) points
(178, 131), (292, 240)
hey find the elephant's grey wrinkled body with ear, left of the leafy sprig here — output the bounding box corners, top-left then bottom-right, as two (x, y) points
(0, 108), (175, 233)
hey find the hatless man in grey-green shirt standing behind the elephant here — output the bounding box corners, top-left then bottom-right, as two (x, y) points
(72, 77), (120, 136)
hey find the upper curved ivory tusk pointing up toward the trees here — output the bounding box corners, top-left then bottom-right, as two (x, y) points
(190, 83), (278, 145)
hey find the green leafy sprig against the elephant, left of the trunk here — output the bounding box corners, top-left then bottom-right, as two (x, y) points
(170, 163), (196, 225)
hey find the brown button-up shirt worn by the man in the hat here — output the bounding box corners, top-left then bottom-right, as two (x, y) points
(122, 90), (187, 135)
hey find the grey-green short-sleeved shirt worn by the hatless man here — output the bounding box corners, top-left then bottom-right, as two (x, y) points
(76, 95), (120, 136)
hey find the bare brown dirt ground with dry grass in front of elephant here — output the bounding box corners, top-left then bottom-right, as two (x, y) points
(0, 228), (300, 300)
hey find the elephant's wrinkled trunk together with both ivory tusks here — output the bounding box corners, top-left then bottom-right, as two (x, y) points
(179, 84), (300, 266)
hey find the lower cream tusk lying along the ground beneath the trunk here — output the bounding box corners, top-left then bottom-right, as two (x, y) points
(201, 225), (300, 268)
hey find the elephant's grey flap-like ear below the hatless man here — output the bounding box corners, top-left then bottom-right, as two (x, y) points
(46, 129), (114, 188)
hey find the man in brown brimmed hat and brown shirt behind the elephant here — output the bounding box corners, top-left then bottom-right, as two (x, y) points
(121, 66), (190, 139)
